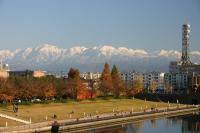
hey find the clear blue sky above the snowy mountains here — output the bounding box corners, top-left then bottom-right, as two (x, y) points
(0, 0), (200, 51)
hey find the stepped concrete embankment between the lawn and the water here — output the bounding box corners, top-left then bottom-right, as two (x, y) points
(0, 105), (200, 133)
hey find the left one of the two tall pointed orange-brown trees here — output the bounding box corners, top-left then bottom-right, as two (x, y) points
(99, 63), (113, 96)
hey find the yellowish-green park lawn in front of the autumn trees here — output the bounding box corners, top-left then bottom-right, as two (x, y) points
(0, 99), (175, 122)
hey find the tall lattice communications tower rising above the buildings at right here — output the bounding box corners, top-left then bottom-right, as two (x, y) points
(181, 24), (191, 65)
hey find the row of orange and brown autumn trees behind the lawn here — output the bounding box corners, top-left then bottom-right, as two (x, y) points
(0, 63), (144, 102)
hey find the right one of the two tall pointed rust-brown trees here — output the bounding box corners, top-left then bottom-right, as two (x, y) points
(111, 65), (124, 98)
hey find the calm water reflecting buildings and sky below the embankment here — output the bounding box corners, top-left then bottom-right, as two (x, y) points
(76, 113), (200, 133)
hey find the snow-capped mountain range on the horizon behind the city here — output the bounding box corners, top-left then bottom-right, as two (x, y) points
(0, 44), (200, 71)
